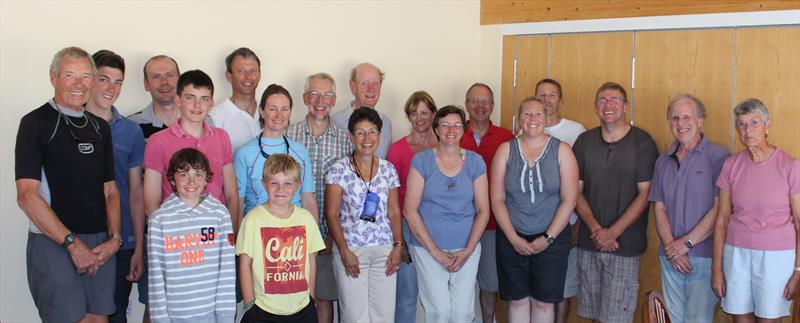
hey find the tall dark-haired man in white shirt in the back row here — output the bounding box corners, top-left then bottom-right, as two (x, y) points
(208, 47), (261, 151)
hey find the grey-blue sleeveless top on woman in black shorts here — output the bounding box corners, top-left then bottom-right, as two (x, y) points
(505, 137), (561, 235)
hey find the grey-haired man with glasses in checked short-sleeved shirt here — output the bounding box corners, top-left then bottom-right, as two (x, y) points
(286, 73), (354, 323)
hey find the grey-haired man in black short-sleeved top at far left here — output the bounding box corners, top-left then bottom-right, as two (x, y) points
(15, 47), (122, 322)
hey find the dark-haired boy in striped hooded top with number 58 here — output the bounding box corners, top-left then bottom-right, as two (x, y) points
(147, 148), (236, 322)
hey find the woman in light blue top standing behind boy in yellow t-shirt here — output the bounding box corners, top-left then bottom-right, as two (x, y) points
(233, 84), (319, 222)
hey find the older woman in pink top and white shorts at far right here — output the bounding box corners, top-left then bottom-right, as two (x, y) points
(711, 99), (800, 322)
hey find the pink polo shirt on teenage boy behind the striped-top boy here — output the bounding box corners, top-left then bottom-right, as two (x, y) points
(144, 122), (233, 204)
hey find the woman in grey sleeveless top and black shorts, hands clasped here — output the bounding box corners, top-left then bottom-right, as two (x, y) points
(491, 97), (578, 322)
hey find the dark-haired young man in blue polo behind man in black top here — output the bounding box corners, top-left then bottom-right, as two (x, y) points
(86, 50), (147, 322)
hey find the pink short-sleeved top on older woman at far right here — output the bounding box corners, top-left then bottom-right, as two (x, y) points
(717, 149), (800, 250)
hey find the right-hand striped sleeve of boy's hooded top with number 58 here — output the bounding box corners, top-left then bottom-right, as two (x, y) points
(215, 204), (236, 322)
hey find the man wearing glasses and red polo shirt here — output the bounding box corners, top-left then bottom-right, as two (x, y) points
(461, 83), (514, 323)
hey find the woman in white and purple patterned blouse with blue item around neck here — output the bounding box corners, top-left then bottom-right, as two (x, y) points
(325, 107), (402, 322)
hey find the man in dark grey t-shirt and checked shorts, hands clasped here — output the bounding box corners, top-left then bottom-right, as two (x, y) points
(573, 82), (658, 322)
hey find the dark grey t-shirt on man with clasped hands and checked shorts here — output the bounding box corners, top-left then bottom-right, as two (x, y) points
(572, 127), (658, 257)
